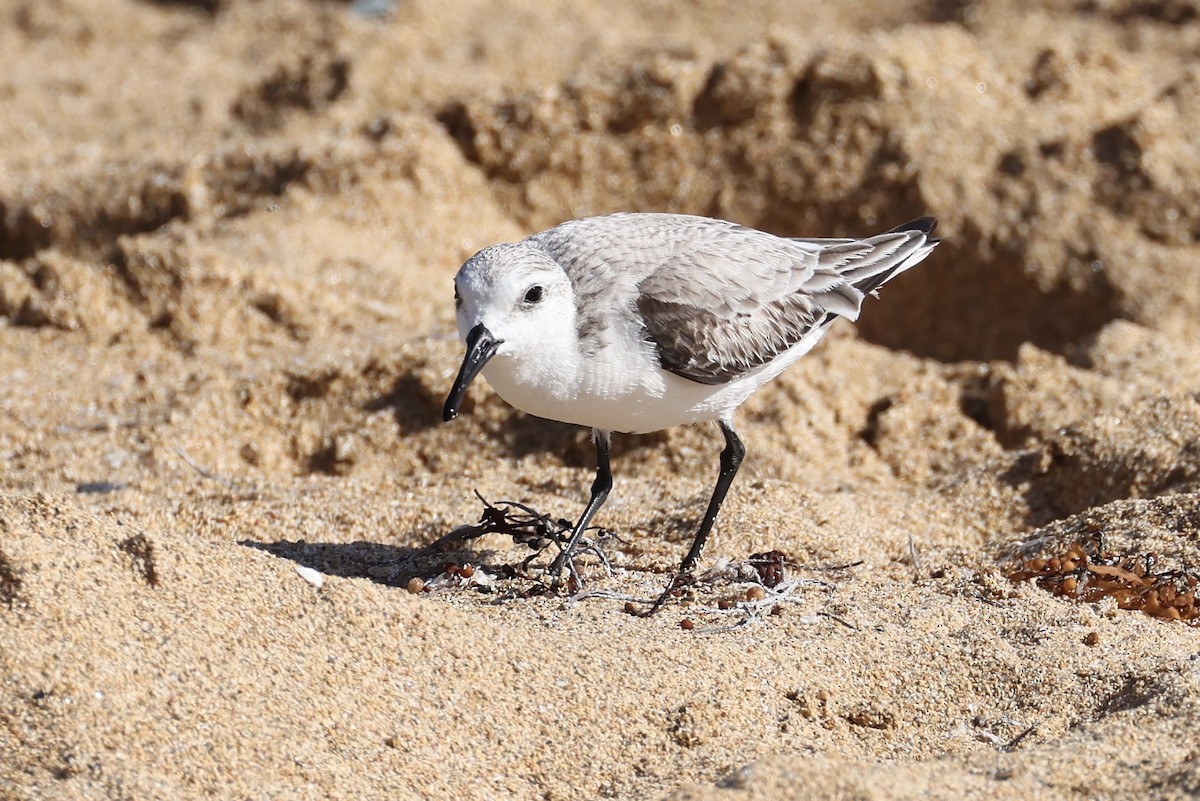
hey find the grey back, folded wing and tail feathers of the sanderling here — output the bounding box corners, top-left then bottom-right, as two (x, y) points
(530, 213), (936, 384)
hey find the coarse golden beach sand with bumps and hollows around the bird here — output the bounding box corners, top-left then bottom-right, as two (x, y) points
(0, 0), (1200, 800)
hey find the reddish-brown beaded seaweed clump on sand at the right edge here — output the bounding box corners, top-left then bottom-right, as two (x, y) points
(1008, 541), (1200, 626)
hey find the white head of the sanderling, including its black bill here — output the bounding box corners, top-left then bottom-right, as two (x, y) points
(442, 242), (576, 420)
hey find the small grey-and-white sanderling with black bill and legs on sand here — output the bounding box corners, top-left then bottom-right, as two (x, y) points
(442, 213), (938, 576)
